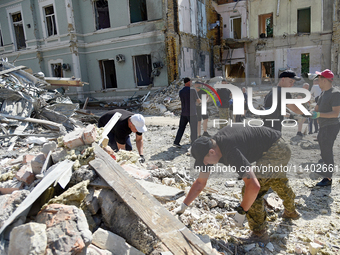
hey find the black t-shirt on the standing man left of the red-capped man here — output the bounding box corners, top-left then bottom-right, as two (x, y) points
(262, 87), (292, 131)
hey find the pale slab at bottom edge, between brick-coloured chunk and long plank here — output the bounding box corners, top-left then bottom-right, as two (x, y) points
(92, 228), (144, 255)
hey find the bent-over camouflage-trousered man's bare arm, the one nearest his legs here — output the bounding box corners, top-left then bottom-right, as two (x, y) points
(240, 169), (261, 212)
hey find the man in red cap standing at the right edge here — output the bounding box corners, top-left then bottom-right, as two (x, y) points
(312, 69), (340, 187)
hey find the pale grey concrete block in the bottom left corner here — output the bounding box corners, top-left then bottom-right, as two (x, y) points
(8, 222), (47, 255)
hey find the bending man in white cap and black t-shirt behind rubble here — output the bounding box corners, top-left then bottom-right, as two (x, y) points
(98, 109), (147, 163)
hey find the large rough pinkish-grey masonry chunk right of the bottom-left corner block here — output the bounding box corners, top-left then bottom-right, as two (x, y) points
(36, 204), (92, 254)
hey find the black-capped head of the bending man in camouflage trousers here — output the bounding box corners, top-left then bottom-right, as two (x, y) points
(191, 136), (222, 168)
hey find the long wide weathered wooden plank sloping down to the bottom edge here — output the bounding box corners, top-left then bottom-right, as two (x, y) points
(90, 143), (217, 255)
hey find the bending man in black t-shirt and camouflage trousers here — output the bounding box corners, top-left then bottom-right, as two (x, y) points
(175, 126), (300, 237)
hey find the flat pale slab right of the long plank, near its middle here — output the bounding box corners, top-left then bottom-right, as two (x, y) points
(137, 180), (185, 201)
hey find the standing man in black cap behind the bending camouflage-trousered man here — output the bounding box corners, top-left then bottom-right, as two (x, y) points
(263, 70), (303, 132)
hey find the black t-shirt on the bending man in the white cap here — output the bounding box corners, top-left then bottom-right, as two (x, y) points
(98, 109), (142, 144)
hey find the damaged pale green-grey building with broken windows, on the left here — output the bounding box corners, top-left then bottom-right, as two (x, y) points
(0, 0), (219, 101)
